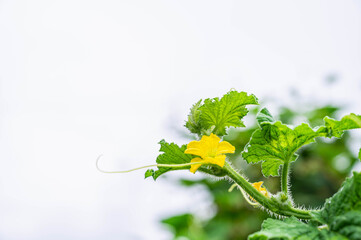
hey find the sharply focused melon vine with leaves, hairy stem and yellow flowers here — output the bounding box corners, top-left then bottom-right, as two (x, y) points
(101, 90), (361, 240)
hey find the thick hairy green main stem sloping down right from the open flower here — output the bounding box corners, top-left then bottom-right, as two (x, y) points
(223, 162), (311, 219)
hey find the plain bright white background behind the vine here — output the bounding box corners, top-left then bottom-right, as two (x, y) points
(0, 0), (361, 240)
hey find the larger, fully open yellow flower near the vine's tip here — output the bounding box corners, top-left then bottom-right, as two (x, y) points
(184, 133), (235, 173)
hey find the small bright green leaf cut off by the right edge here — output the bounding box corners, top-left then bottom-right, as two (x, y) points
(324, 113), (361, 138)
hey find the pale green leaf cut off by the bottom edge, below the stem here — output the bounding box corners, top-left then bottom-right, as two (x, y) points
(248, 217), (347, 240)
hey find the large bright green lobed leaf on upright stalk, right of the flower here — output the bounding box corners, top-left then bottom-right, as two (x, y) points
(242, 109), (321, 177)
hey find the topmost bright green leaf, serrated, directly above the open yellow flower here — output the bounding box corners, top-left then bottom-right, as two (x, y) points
(185, 91), (258, 136)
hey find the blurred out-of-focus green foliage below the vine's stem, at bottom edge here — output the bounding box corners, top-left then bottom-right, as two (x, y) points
(162, 178), (267, 240)
